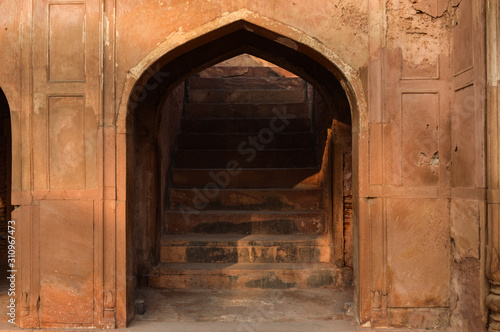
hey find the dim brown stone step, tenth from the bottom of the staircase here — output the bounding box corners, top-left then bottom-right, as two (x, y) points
(187, 88), (306, 104)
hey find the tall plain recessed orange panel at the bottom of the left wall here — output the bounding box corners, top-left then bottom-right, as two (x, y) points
(39, 200), (94, 324)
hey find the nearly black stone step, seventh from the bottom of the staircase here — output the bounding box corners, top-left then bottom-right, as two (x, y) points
(177, 132), (315, 151)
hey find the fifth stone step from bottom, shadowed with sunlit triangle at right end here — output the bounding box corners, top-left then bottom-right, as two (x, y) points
(172, 167), (320, 190)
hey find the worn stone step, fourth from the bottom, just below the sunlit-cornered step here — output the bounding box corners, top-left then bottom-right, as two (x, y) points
(169, 188), (324, 211)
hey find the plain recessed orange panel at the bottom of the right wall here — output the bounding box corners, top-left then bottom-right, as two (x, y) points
(387, 198), (450, 308)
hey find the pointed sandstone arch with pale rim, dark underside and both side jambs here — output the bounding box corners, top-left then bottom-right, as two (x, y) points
(116, 9), (371, 323)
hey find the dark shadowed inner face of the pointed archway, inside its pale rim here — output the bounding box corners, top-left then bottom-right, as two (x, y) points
(118, 17), (368, 324)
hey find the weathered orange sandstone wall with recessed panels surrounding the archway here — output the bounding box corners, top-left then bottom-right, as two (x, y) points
(0, 0), (487, 331)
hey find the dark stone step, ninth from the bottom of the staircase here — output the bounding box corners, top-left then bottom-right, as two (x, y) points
(184, 103), (309, 119)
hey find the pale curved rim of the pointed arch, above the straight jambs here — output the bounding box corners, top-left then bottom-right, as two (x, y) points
(117, 9), (367, 133)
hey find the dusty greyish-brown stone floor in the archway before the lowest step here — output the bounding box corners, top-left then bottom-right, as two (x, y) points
(136, 288), (353, 326)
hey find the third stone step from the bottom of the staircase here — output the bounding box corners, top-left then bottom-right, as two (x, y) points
(165, 211), (326, 235)
